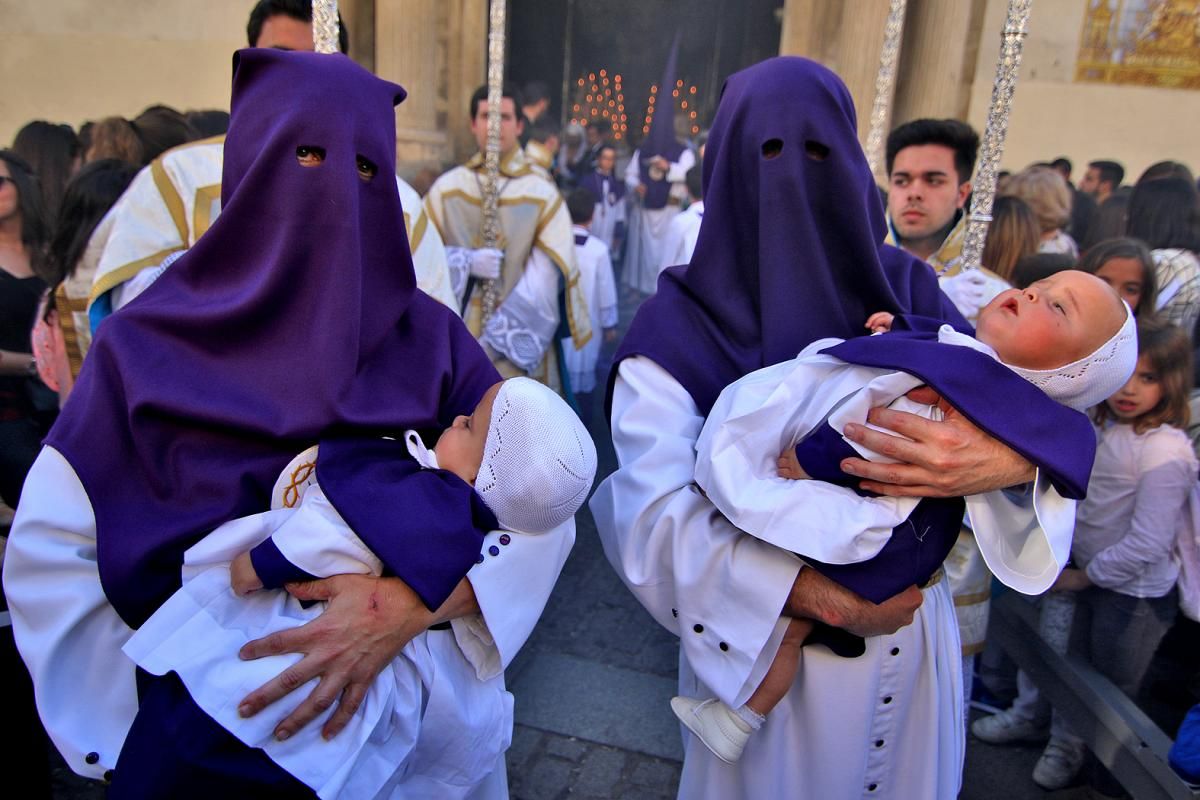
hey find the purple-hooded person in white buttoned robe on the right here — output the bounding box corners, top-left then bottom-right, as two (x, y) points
(592, 58), (1064, 800)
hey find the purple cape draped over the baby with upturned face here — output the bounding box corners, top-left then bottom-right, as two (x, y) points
(822, 320), (1096, 500)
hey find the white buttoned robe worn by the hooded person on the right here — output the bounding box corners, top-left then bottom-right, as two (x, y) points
(592, 357), (1070, 800)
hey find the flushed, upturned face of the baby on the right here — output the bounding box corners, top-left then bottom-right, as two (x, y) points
(976, 270), (1126, 369)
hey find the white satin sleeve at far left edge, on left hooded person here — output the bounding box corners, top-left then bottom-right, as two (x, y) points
(4, 447), (138, 778)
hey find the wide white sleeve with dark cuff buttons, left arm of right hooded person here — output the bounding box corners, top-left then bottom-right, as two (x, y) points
(592, 357), (800, 708)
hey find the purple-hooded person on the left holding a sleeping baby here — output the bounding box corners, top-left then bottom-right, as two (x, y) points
(5, 49), (572, 798)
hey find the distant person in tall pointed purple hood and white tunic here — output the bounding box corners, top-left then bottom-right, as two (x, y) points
(622, 38), (696, 294)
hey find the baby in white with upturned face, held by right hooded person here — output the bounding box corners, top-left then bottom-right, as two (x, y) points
(671, 271), (1136, 763)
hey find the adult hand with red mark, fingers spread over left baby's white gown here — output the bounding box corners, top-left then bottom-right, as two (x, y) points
(238, 575), (479, 740)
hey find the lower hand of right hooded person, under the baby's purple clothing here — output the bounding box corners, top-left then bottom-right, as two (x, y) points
(785, 567), (924, 637)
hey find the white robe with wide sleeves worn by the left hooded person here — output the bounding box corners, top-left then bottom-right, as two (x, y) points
(4, 447), (575, 799)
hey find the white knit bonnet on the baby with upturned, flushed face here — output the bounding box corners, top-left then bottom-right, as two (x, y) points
(1007, 300), (1138, 411)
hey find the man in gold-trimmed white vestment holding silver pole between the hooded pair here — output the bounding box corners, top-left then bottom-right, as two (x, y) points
(425, 85), (592, 390)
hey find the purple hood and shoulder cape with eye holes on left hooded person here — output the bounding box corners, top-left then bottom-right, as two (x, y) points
(47, 49), (498, 627)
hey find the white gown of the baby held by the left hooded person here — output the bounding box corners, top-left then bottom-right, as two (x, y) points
(124, 470), (540, 800)
